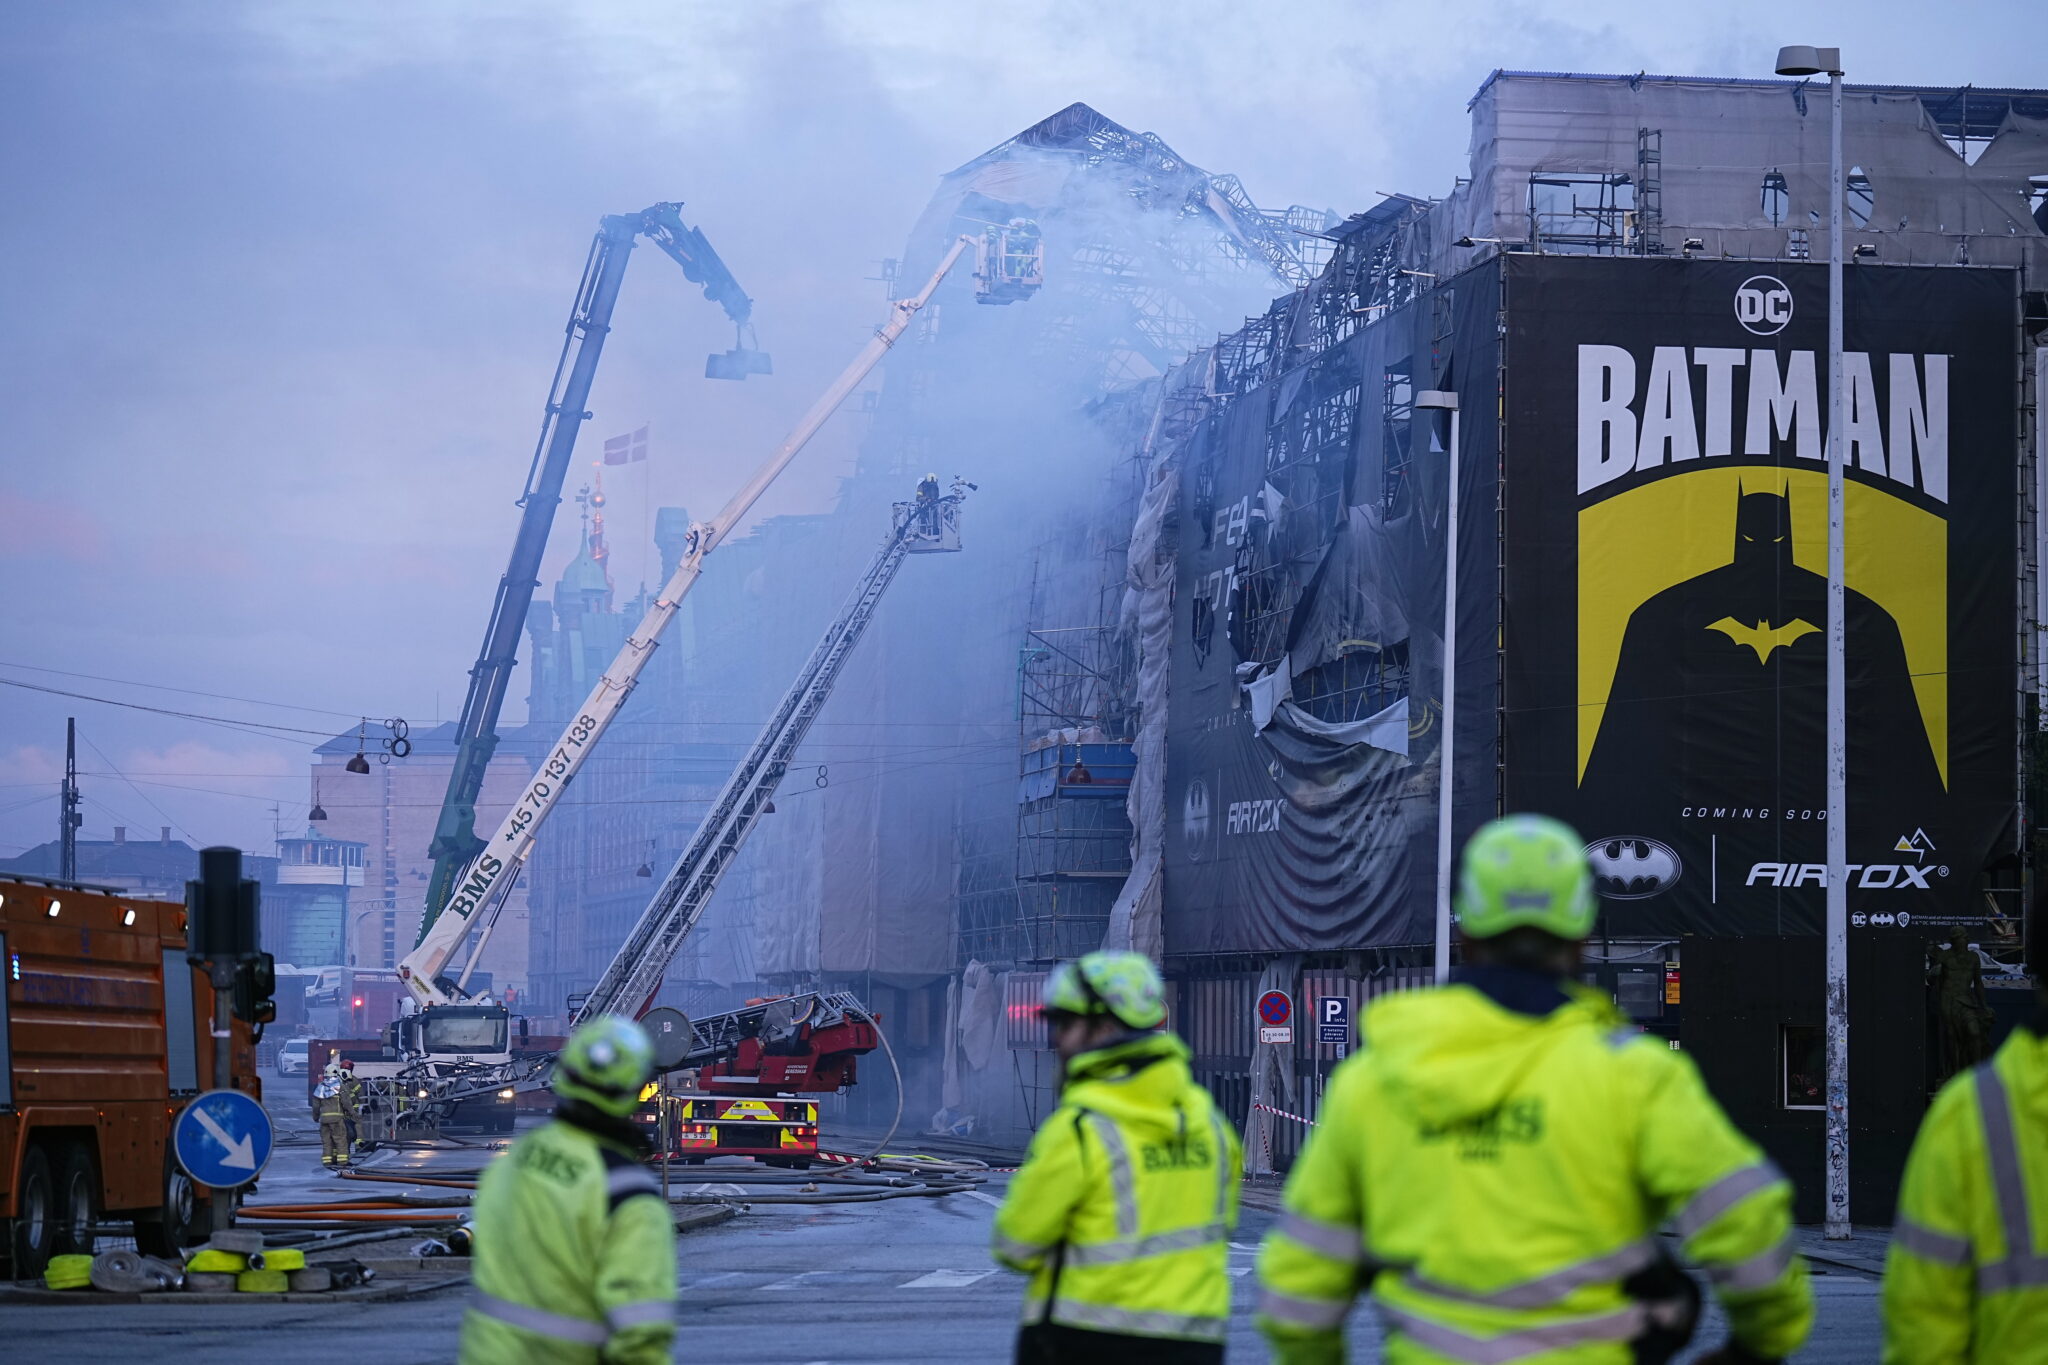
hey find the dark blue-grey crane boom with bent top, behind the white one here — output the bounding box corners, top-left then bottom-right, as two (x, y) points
(420, 203), (766, 941)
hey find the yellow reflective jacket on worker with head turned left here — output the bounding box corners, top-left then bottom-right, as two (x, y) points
(993, 1033), (1243, 1342)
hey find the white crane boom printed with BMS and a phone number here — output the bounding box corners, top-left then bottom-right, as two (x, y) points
(397, 235), (1011, 1005)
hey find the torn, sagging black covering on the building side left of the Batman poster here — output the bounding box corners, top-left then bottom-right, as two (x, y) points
(1165, 264), (1499, 954)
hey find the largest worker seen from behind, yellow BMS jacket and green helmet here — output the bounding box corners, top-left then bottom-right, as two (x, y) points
(1260, 814), (1812, 1365)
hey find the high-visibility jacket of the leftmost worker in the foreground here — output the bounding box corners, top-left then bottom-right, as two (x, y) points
(461, 1117), (676, 1365)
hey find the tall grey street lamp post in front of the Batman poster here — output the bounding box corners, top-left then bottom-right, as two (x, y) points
(1778, 47), (1849, 1242)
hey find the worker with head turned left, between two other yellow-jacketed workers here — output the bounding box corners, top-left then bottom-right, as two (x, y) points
(993, 952), (1243, 1365)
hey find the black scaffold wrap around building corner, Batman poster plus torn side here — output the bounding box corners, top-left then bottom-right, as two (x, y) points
(1165, 254), (2019, 956)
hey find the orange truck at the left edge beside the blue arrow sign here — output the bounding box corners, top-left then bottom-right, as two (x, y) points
(0, 876), (262, 1277)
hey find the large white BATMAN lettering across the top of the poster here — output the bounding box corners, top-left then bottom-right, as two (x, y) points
(1579, 346), (1948, 503)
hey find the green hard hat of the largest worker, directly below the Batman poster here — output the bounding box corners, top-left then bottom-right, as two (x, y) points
(1456, 814), (1599, 941)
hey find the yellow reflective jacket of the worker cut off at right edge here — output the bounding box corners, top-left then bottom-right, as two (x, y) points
(1884, 1029), (2048, 1365)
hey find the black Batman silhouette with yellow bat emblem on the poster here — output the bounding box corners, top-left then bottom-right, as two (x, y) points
(1581, 491), (1942, 822)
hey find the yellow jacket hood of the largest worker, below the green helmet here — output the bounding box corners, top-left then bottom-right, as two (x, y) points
(1360, 984), (1628, 1124)
